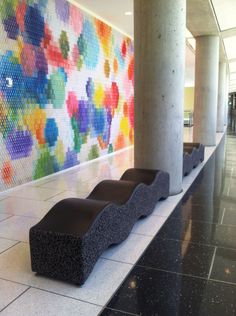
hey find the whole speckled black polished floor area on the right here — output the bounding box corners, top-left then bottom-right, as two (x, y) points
(101, 131), (236, 316)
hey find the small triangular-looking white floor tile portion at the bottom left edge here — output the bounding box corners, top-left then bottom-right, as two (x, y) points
(0, 279), (28, 315)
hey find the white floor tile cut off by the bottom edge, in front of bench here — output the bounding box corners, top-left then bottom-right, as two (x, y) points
(1, 288), (102, 316)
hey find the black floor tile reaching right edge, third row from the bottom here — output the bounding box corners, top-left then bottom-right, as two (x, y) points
(157, 217), (236, 249)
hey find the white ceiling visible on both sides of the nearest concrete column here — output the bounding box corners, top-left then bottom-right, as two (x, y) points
(74, 0), (236, 91)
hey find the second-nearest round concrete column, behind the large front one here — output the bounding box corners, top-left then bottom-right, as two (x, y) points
(193, 36), (219, 146)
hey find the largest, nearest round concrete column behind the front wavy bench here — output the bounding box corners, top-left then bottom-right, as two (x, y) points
(134, 0), (186, 195)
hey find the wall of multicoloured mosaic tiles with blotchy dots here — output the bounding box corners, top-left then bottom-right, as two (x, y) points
(0, 0), (134, 191)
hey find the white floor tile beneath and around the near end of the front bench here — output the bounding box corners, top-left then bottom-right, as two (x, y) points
(0, 243), (132, 306)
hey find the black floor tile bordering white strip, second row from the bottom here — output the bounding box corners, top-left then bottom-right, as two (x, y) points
(137, 238), (215, 278)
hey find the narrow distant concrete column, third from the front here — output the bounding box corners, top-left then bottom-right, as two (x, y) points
(216, 62), (226, 132)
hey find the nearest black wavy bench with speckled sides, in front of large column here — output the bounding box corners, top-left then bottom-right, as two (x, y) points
(30, 169), (169, 285)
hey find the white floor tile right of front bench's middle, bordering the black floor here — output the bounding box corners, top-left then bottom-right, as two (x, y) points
(102, 234), (152, 264)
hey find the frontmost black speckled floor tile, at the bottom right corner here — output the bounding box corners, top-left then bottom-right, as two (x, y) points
(108, 267), (236, 316)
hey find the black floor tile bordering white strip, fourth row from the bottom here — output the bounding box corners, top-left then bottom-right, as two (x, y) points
(171, 199), (224, 223)
